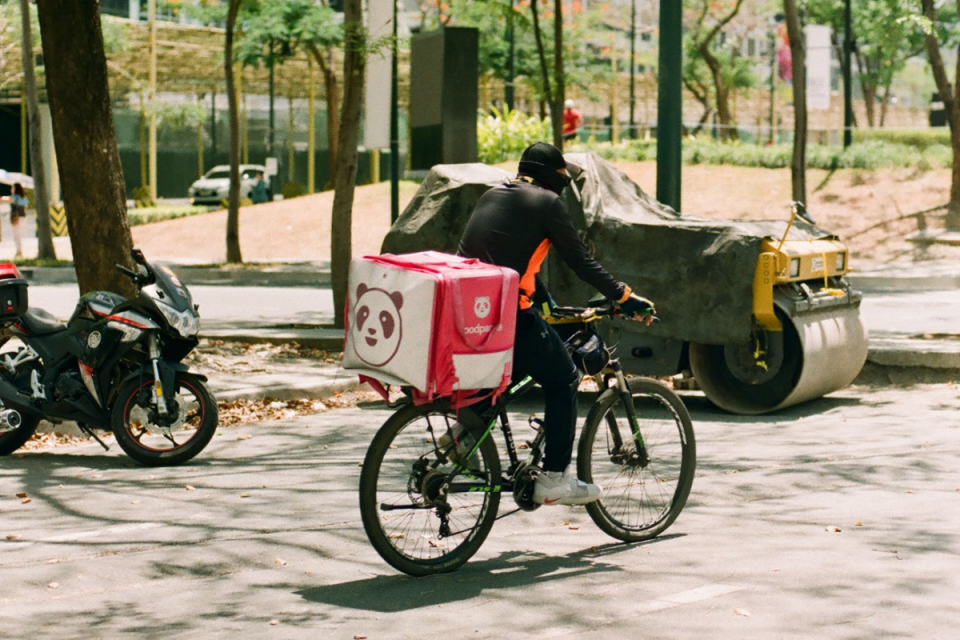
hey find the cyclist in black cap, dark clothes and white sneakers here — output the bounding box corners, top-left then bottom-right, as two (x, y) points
(459, 142), (656, 504)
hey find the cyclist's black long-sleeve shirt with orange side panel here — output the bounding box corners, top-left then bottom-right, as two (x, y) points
(459, 180), (626, 309)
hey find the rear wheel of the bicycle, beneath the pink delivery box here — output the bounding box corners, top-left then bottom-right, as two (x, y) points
(360, 402), (500, 576)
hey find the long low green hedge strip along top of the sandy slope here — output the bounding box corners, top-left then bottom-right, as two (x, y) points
(590, 138), (953, 170)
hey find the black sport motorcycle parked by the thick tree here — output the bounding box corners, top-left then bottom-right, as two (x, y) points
(0, 249), (219, 466)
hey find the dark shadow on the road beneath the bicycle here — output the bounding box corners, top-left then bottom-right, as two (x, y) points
(296, 533), (686, 613)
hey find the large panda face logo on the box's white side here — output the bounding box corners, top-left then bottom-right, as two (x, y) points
(353, 284), (403, 367)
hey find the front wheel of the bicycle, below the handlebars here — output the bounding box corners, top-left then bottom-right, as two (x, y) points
(577, 379), (697, 542)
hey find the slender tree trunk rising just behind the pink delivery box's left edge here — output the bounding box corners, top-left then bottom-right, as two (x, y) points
(330, 0), (366, 327)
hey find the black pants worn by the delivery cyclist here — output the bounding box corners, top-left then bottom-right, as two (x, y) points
(513, 309), (580, 471)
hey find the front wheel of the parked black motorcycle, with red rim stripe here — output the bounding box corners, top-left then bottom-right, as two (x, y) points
(112, 373), (220, 467)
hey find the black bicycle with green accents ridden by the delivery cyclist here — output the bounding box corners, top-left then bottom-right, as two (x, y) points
(360, 299), (696, 576)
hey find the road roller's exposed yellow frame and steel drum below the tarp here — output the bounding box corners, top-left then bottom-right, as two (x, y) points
(611, 203), (867, 415)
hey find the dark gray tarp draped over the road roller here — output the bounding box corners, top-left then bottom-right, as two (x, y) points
(383, 153), (829, 344)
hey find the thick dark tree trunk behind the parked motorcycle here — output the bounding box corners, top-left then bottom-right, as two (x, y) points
(37, 0), (136, 297)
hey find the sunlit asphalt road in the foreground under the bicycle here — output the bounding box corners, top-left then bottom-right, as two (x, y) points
(0, 385), (960, 639)
